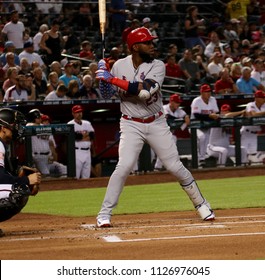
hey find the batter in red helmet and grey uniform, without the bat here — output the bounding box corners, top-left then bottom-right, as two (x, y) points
(96, 27), (215, 227)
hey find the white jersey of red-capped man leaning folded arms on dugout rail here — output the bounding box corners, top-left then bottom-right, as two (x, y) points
(191, 96), (219, 119)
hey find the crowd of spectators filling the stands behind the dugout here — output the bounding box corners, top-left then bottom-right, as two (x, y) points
(0, 0), (265, 101)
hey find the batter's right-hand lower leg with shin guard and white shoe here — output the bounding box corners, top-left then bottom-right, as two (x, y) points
(182, 181), (215, 221)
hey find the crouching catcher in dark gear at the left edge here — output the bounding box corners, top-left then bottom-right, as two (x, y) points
(0, 108), (41, 236)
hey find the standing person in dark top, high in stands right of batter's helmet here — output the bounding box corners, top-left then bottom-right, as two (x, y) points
(184, 6), (205, 49)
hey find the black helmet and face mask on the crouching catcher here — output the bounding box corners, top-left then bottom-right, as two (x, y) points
(0, 108), (26, 140)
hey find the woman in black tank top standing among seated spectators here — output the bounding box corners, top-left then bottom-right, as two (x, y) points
(40, 19), (64, 66)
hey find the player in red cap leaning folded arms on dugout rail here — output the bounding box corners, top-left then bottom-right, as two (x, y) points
(191, 84), (219, 166)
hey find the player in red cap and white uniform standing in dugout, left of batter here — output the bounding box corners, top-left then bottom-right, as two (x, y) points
(68, 105), (95, 179)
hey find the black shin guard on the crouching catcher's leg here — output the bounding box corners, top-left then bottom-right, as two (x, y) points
(0, 184), (31, 222)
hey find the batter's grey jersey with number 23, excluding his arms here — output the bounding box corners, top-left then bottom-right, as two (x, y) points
(111, 55), (165, 118)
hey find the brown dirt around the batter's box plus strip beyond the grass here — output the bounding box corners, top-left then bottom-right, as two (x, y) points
(0, 167), (265, 260)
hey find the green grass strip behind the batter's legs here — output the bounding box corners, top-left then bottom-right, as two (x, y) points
(23, 176), (265, 216)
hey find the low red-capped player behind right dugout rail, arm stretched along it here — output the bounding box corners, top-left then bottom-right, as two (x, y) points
(207, 104), (248, 167)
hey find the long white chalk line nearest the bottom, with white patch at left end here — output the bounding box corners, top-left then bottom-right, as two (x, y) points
(102, 232), (265, 243)
